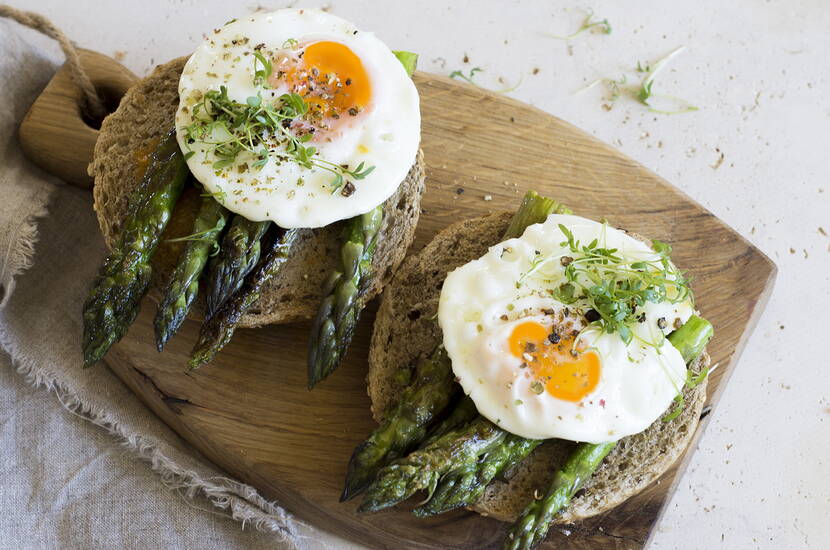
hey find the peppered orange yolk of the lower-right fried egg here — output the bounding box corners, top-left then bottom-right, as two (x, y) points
(508, 321), (601, 401)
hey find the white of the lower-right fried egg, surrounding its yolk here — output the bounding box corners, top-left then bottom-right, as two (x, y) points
(438, 215), (693, 443)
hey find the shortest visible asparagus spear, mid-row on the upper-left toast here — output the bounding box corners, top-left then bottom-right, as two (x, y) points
(207, 216), (271, 318)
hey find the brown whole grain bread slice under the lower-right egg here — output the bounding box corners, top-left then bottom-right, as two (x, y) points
(367, 212), (709, 523)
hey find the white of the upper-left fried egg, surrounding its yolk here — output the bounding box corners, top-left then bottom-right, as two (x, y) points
(176, 9), (421, 228)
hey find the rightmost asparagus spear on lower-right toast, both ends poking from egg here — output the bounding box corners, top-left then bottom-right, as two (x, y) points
(504, 315), (713, 550)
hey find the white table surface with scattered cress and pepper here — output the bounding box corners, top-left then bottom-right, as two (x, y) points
(9, 0), (830, 550)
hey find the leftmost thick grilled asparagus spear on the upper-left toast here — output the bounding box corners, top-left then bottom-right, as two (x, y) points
(83, 131), (188, 367)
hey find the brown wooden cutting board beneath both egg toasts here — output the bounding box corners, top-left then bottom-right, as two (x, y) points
(20, 52), (776, 549)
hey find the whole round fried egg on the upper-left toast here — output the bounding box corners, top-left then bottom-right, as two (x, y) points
(176, 9), (421, 228)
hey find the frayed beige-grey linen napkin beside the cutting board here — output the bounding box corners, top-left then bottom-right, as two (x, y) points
(0, 19), (354, 548)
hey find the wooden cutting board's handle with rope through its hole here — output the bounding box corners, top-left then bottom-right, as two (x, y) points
(19, 50), (138, 188)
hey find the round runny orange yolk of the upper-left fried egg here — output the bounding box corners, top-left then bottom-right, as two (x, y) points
(272, 41), (372, 119)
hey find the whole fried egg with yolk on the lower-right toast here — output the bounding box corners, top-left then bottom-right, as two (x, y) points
(438, 215), (694, 443)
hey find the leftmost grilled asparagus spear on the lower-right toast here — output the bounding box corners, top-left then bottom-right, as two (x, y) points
(340, 348), (456, 501)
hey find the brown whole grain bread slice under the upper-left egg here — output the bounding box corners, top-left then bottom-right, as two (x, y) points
(89, 58), (424, 327)
